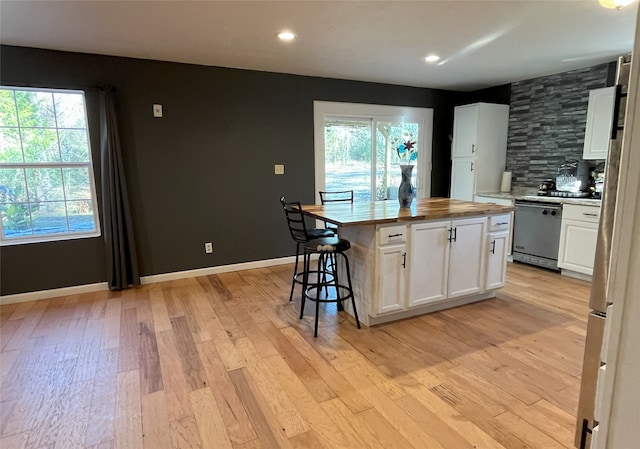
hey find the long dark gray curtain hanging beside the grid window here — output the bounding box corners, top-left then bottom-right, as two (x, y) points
(100, 86), (140, 290)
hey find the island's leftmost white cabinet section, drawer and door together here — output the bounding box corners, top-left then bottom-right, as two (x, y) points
(376, 226), (407, 314)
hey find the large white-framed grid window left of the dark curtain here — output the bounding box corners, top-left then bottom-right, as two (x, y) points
(0, 86), (100, 245)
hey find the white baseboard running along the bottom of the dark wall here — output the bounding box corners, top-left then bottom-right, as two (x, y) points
(0, 256), (296, 305)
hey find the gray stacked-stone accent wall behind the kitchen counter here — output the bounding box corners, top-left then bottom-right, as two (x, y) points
(507, 62), (615, 188)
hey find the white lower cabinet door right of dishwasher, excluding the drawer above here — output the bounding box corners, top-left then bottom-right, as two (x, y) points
(558, 218), (598, 275)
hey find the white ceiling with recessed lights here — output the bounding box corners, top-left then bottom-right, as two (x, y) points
(0, 0), (637, 90)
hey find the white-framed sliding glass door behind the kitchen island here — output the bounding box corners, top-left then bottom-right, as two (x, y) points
(314, 101), (433, 202)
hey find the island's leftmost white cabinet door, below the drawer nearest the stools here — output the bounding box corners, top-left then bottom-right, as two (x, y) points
(377, 245), (407, 313)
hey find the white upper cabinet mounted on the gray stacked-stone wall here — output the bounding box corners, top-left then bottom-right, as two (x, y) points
(582, 86), (616, 159)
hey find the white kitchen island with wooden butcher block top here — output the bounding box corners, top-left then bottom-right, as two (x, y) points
(303, 198), (513, 326)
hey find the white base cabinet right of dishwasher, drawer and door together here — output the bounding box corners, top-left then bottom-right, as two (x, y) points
(558, 204), (600, 275)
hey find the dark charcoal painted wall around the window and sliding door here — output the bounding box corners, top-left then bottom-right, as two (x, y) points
(0, 46), (496, 295)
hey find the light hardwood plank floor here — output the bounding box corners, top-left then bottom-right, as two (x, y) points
(0, 264), (589, 449)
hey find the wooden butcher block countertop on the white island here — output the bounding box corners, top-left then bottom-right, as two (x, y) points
(302, 198), (514, 226)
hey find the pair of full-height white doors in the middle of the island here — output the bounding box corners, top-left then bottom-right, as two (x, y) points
(407, 217), (487, 307)
